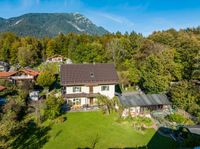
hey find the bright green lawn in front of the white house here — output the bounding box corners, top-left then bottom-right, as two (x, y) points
(43, 112), (177, 149)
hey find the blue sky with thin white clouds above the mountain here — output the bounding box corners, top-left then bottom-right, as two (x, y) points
(0, 0), (200, 35)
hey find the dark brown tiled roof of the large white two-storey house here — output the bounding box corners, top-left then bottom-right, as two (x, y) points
(61, 64), (118, 85)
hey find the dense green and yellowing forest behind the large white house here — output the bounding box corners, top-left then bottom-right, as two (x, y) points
(0, 27), (200, 119)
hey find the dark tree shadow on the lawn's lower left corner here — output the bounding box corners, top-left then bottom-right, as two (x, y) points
(12, 122), (50, 149)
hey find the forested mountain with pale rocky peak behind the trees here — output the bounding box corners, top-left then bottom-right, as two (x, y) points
(0, 13), (108, 37)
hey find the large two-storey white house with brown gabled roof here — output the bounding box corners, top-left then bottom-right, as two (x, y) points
(61, 64), (118, 106)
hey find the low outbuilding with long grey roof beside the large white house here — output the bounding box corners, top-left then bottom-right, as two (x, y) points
(119, 93), (171, 116)
